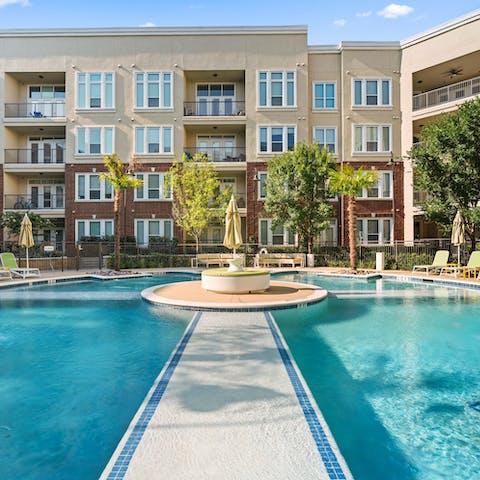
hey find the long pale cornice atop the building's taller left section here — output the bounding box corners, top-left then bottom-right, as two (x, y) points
(0, 25), (308, 37)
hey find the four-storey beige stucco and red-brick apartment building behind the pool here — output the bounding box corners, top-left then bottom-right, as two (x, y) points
(0, 9), (479, 249)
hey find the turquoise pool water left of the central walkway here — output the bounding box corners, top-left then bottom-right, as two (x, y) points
(0, 275), (192, 480)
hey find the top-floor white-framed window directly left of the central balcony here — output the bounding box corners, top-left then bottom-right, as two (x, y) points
(135, 72), (173, 108)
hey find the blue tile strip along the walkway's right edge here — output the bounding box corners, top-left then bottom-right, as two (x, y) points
(265, 312), (347, 480)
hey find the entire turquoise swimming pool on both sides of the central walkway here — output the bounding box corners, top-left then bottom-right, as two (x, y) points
(0, 274), (480, 480)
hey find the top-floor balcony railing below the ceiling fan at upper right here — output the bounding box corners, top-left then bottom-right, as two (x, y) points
(413, 77), (480, 111)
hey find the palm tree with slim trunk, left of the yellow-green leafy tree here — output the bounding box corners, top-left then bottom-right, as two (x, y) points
(100, 154), (143, 271)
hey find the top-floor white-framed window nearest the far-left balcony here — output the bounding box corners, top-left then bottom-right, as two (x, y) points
(77, 73), (115, 109)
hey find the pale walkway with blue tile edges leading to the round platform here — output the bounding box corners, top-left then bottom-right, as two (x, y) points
(101, 312), (351, 480)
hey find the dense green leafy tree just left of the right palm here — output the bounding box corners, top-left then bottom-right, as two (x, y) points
(264, 143), (334, 253)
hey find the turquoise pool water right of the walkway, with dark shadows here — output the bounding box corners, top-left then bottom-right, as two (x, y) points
(273, 275), (480, 480)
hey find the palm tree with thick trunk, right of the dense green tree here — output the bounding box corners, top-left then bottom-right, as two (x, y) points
(330, 164), (378, 271)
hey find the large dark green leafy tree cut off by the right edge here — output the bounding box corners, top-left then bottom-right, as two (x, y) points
(410, 98), (480, 250)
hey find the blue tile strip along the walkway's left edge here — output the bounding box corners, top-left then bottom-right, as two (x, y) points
(107, 312), (202, 480)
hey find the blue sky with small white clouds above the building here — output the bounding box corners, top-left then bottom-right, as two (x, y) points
(0, 0), (480, 44)
